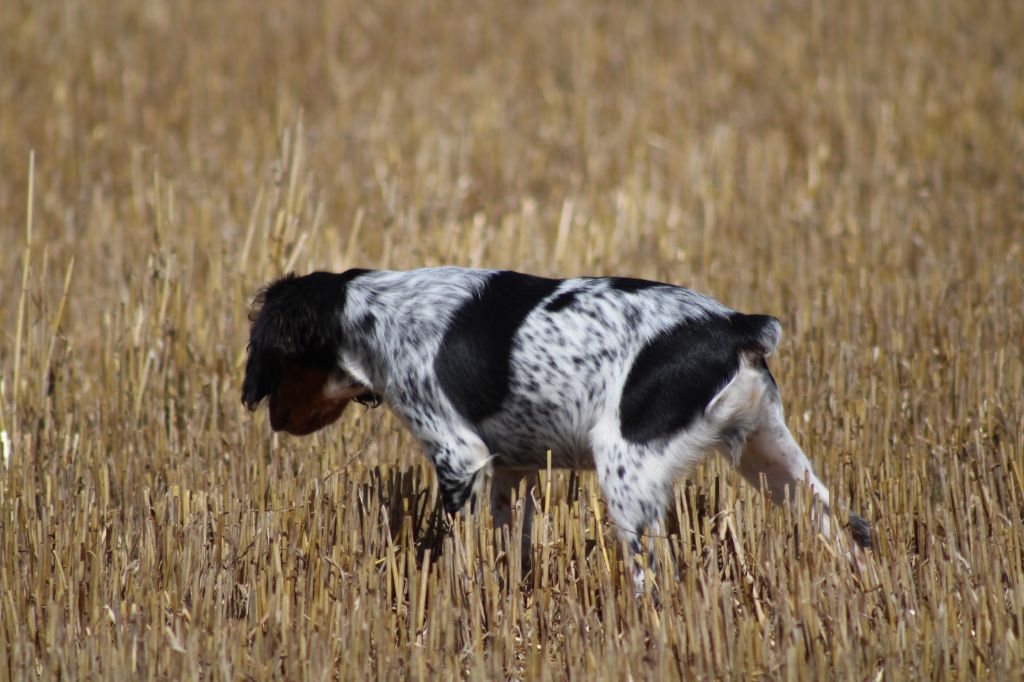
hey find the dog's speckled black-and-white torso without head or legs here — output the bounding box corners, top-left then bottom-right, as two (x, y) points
(335, 267), (778, 469)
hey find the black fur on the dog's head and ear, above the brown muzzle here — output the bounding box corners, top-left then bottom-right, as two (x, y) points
(242, 269), (368, 410)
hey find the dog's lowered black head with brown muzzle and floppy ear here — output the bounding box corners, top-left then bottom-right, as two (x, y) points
(242, 270), (370, 435)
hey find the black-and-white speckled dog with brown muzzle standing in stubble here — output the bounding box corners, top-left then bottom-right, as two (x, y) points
(242, 267), (870, 569)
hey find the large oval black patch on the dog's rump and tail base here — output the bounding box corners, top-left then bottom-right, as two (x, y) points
(618, 312), (772, 443)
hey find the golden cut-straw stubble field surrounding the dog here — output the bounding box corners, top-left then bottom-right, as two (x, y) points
(0, 0), (1024, 680)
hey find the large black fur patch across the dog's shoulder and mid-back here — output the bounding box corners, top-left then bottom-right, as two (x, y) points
(434, 270), (562, 423)
